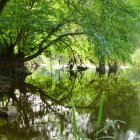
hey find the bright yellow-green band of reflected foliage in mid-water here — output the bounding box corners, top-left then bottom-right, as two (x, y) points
(27, 69), (139, 108)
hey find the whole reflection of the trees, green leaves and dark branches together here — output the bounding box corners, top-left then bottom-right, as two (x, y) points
(0, 67), (139, 139)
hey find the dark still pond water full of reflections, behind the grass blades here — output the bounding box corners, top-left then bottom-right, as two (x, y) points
(0, 64), (140, 140)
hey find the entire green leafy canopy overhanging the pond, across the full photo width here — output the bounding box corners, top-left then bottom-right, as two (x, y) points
(0, 0), (139, 63)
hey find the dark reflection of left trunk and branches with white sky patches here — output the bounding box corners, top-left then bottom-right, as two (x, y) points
(0, 71), (70, 140)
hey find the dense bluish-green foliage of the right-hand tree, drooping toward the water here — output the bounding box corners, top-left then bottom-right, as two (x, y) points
(74, 0), (138, 65)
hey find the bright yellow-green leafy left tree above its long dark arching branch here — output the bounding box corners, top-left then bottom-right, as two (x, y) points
(0, 0), (83, 61)
